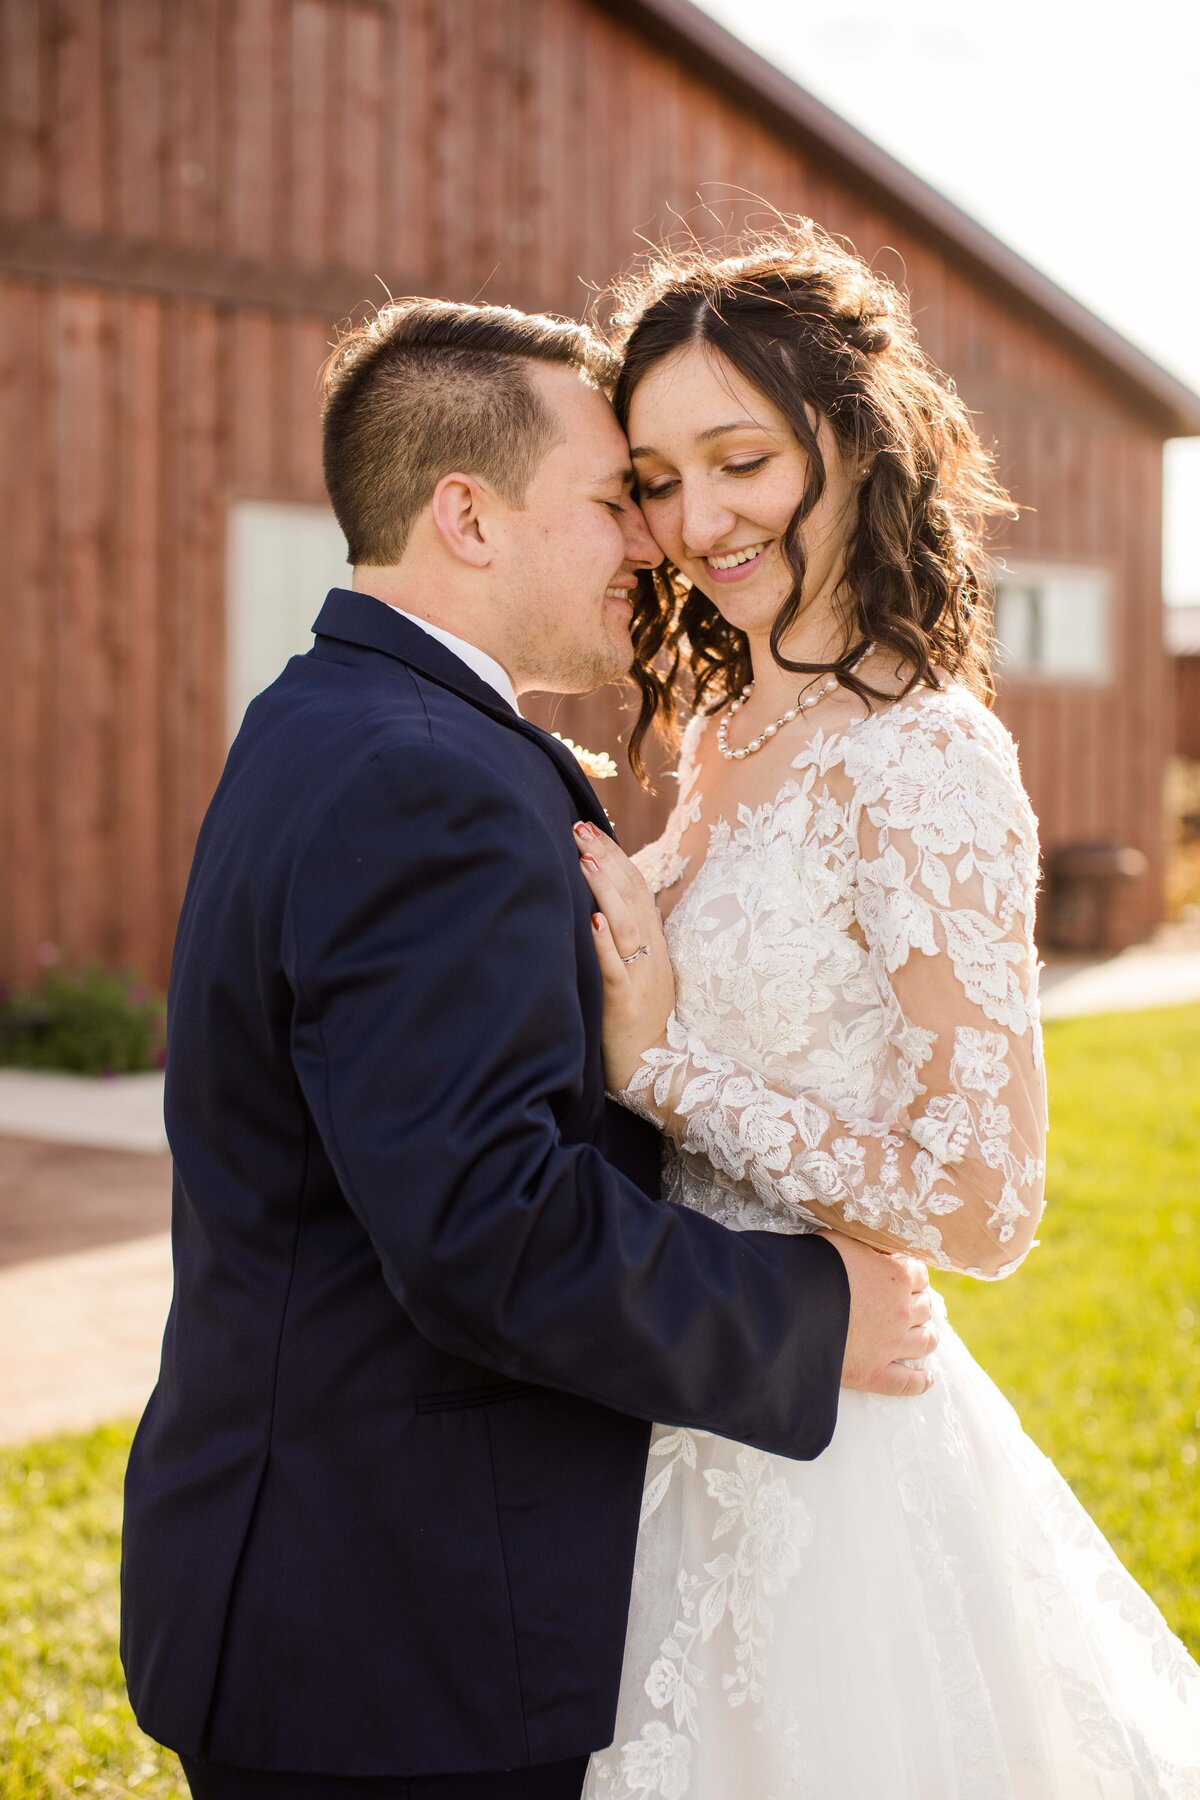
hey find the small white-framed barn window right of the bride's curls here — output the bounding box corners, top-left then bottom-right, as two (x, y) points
(997, 563), (1112, 684)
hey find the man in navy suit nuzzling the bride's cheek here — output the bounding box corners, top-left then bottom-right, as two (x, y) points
(122, 302), (932, 1800)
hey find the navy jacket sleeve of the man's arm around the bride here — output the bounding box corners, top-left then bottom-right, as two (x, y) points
(284, 745), (849, 1458)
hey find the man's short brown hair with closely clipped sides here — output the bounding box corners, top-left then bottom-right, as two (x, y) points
(322, 299), (617, 567)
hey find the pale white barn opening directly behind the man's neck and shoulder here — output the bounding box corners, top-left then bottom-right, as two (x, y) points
(225, 500), (349, 738)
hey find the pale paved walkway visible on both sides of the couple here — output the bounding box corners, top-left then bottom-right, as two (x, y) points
(0, 932), (1200, 1444)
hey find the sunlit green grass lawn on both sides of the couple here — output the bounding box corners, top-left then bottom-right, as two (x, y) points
(0, 1006), (1200, 1800)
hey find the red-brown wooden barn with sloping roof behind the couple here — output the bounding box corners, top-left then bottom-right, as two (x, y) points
(0, 0), (1200, 979)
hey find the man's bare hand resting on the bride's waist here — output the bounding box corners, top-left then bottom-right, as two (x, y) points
(820, 1231), (937, 1397)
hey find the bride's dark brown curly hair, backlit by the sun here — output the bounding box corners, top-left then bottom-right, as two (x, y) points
(610, 220), (1015, 785)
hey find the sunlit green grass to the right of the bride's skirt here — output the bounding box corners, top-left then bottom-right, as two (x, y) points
(937, 1006), (1200, 1656)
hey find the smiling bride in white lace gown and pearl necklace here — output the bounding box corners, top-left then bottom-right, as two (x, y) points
(579, 223), (1200, 1800)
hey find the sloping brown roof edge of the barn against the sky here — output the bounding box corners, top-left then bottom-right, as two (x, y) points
(601, 0), (1200, 437)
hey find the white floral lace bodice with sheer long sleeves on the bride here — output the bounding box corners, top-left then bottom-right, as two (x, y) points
(624, 686), (1045, 1274)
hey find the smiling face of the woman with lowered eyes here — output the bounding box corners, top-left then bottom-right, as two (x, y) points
(628, 344), (856, 637)
